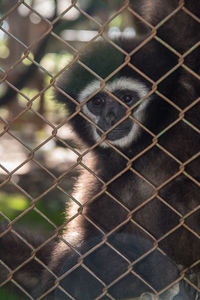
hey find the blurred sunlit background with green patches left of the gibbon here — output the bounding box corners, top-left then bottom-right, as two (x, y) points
(0, 0), (144, 300)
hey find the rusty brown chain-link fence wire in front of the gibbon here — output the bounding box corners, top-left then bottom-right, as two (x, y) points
(0, 1), (200, 300)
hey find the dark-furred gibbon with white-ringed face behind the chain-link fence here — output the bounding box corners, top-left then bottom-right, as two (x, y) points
(0, 0), (200, 300)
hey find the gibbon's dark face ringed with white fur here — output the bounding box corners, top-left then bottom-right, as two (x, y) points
(78, 77), (150, 148)
